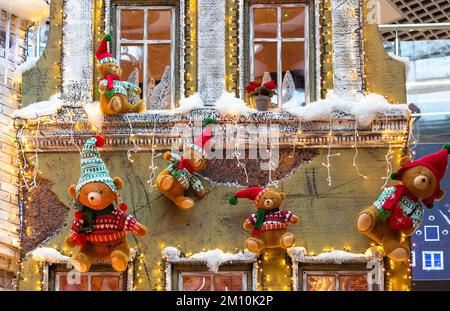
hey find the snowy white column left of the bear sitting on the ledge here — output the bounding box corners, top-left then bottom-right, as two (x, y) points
(62, 0), (93, 107)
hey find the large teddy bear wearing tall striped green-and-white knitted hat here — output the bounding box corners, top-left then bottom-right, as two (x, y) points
(65, 136), (148, 272)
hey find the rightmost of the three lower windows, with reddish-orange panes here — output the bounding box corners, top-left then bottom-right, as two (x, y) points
(303, 271), (372, 291)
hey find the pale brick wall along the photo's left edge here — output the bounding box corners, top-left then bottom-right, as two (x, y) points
(0, 10), (27, 290)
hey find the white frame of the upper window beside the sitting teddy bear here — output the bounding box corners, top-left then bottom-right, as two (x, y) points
(115, 5), (176, 110)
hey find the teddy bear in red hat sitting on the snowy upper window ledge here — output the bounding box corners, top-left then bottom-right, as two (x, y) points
(95, 34), (146, 116)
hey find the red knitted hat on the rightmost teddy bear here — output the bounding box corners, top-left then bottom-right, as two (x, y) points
(393, 145), (450, 205)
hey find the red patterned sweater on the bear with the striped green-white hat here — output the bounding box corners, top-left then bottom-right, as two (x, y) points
(69, 209), (139, 244)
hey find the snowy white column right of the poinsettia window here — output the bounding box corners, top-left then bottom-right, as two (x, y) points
(331, 0), (363, 97)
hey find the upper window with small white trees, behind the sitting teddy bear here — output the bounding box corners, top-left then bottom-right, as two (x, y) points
(117, 6), (175, 110)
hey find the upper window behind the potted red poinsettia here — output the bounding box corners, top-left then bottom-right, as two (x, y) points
(250, 4), (308, 107)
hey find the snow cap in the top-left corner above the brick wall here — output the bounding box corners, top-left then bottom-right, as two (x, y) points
(0, 0), (50, 21)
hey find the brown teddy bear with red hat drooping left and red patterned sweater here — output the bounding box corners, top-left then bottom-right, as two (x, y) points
(229, 187), (299, 253)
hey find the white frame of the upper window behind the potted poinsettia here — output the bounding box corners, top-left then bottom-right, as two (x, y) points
(248, 3), (310, 109)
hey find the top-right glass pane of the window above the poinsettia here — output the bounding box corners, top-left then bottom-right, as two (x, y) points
(281, 7), (305, 38)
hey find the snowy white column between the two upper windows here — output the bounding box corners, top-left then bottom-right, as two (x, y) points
(197, 0), (225, 106)
